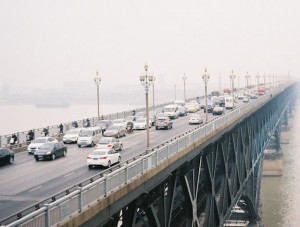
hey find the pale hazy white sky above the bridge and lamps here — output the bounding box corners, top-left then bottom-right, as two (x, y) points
(0, 0), (300, 98)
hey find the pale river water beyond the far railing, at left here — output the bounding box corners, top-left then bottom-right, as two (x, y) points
(0, 104), (136, 135)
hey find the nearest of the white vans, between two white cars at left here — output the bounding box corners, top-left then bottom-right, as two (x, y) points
(77, 127), (102, 147)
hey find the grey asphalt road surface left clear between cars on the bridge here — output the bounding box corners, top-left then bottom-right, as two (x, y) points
(0, 101), (245, 220)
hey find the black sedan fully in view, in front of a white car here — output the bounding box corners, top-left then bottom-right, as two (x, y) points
(34, 142), (67, 161)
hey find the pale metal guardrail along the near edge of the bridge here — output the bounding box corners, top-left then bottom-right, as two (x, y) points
(0, 88), (281, 227)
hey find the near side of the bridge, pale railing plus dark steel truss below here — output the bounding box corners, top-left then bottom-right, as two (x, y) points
(0, 84), (297, 227)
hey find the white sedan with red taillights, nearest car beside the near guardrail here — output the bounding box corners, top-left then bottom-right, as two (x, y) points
(86, 148), (121, 169)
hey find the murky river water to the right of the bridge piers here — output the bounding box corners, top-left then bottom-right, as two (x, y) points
(261, 105), (300, 227)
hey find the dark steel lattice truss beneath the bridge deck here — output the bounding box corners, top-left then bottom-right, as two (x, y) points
(100, 84), (294, 227)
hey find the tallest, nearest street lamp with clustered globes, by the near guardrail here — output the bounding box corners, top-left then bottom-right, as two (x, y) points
(140, 62), (153, 149)
